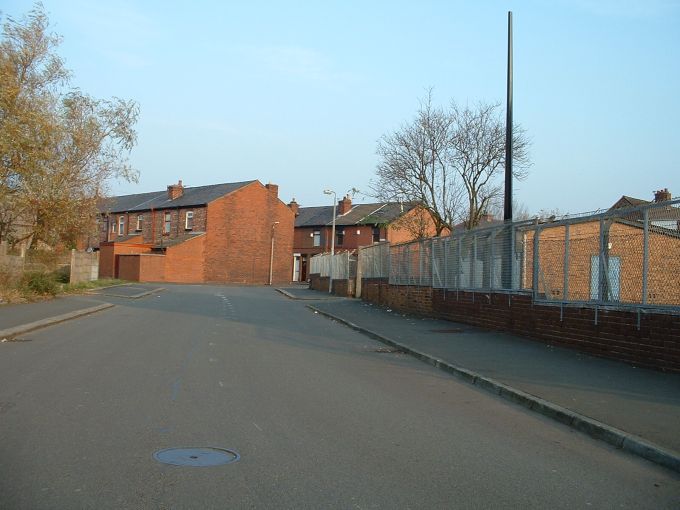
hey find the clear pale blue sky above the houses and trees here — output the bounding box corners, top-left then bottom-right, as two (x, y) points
(0, 0), (680, 214)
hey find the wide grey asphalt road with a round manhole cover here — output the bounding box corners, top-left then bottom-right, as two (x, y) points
(0, 286), (680, 509)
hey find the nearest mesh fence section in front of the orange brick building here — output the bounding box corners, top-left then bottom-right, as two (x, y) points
(524, 200), (680, 307)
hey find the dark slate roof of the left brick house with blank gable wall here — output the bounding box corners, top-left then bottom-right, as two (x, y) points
(99, 181), (257, 212)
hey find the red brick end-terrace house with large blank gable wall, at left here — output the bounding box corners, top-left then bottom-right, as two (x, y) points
(98, 180), (295, 284)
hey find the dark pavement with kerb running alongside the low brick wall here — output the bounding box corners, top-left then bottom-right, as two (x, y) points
(276, 288), (680, 471)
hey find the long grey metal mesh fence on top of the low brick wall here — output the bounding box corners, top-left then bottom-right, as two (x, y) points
(359, 200), (680, 308)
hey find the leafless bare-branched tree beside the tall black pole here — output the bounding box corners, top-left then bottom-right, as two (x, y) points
(371, 91), (529, 235)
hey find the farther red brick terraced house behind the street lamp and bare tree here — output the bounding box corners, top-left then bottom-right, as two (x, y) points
(288, 196), (434, 281)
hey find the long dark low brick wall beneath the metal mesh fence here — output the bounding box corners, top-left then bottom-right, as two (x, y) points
(361, 279), (680, 372)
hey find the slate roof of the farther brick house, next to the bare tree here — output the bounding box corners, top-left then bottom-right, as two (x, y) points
(295, 202), (418, 227)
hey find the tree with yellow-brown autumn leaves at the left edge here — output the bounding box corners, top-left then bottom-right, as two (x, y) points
(0, 4), (138, 249)
